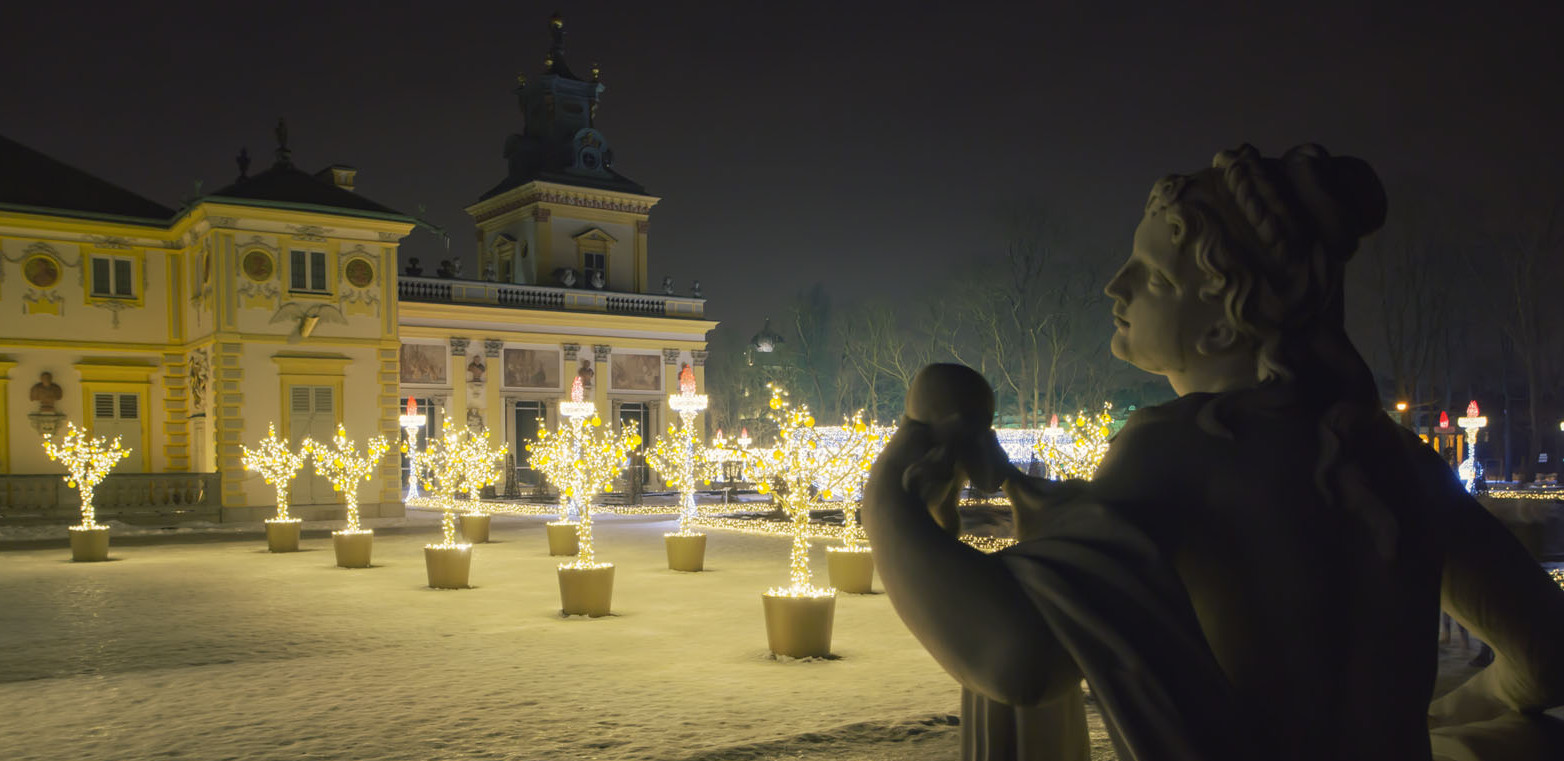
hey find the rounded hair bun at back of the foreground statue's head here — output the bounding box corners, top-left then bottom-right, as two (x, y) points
(1281, 144), (1387, 259)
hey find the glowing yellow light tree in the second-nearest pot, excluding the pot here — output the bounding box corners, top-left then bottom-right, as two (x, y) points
(527, 377), (641, 569)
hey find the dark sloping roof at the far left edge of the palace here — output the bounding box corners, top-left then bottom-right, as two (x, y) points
(0, 136), (174, 223)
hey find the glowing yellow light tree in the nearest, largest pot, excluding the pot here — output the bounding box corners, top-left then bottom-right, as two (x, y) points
(743, 384), (884, 597)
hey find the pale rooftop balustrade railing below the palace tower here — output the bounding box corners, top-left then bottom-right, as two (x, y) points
(397, 275), (705, 317)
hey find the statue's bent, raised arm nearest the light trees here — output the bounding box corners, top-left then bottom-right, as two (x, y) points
(862, 422), (1081, 705)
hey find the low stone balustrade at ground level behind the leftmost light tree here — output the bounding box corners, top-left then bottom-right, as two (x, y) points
(0, 473), (221, 525)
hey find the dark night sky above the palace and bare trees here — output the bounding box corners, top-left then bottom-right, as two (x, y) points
(0, 2), (1564, 337)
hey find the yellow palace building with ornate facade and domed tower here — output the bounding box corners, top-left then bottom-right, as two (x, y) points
(0, 23), (716, 522)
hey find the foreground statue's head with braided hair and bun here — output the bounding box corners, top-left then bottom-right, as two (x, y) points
(1104, 145), (1386, 394)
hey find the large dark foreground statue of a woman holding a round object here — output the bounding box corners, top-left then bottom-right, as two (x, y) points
(863, 145), (1564, 761)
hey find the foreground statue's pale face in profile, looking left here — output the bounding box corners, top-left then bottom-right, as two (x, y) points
(1103, 213), (1225, 377)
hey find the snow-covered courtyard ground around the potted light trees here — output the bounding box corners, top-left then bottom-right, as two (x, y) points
(0, 511), (1488, 761)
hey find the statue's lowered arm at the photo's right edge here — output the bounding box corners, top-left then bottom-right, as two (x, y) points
(1429, 495), (1564, 725)
